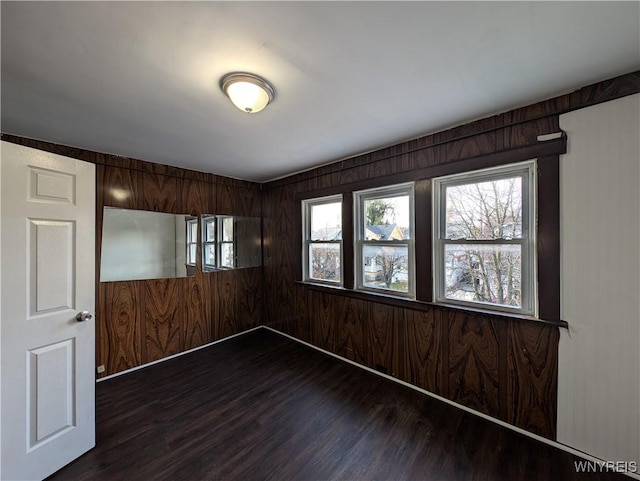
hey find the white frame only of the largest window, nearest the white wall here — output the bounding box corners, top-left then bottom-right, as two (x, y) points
(431, 159), (539, 317)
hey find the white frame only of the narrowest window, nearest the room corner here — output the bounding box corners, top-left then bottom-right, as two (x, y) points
(302, 194), (345, 287)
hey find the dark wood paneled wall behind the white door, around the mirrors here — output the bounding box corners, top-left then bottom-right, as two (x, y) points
(2, 134), (263, 376)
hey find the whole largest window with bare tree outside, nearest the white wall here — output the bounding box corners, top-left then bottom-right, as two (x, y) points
(433, 161), (537, 315)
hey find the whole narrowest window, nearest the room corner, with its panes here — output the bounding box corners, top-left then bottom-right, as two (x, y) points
(302, 195), (342, 285)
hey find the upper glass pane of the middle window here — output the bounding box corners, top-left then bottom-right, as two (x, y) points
(362, 195), (411, 240)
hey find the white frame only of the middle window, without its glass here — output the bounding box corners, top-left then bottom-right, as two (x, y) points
(353, 182), (416, 299)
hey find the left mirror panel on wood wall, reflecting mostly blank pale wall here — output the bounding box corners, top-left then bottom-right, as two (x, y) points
(100, 207), (198, 282)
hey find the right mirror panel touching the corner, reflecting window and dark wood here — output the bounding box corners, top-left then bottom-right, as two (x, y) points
(202, 214), (262, 271)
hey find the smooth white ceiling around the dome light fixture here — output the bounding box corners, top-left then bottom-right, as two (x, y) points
(1, 1), (640, 181)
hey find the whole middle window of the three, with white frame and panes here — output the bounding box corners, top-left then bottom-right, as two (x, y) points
(354, 184), (415, 297)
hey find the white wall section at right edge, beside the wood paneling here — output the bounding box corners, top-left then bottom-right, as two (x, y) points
(558, 94), (640, 463)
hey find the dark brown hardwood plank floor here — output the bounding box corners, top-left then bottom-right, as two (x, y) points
(49, 329), (630, 481)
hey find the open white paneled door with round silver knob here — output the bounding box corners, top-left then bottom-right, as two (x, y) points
(0, 142), (95, 481)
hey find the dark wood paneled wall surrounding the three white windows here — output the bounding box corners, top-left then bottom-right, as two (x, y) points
(263, 72), (640, 439)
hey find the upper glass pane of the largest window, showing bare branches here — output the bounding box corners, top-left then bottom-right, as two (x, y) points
(446, 177), (522, 240)
